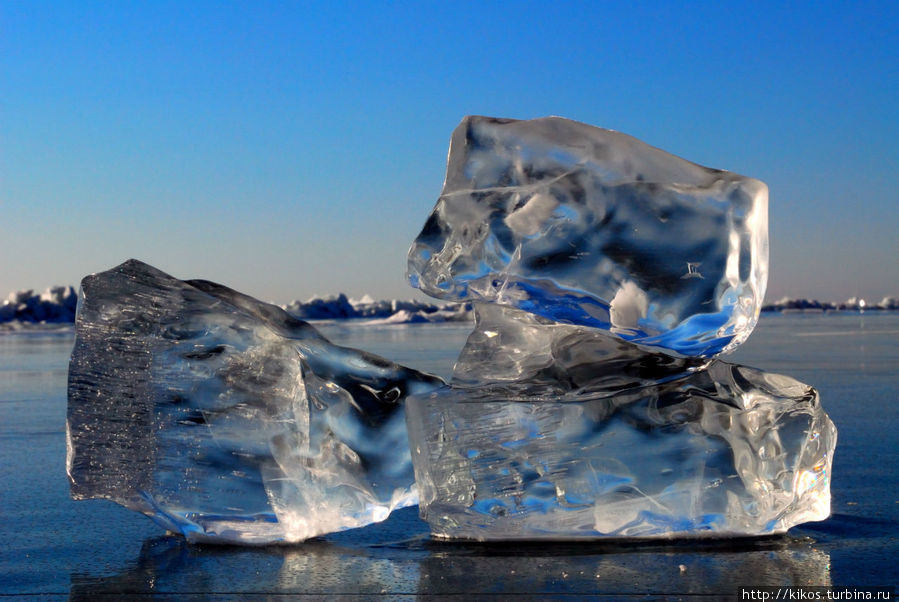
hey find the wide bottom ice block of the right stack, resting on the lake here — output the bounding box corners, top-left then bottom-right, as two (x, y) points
(406, 352), (836, 540)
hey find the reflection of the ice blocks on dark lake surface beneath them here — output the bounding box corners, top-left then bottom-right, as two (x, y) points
(70, 524), (832, 600)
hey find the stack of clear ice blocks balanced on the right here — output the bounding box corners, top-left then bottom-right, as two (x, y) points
(406, 117), (836, 540)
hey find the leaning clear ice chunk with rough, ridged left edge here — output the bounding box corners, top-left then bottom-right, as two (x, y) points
(67, 260), (443, 544)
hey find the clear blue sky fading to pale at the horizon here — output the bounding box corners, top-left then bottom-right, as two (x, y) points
(0, 0), (899, 303)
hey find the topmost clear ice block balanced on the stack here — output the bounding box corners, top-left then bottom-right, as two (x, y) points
(407, 117), (768, 356)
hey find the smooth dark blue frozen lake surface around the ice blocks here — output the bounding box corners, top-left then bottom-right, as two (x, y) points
(0, 312), (899, 599)
